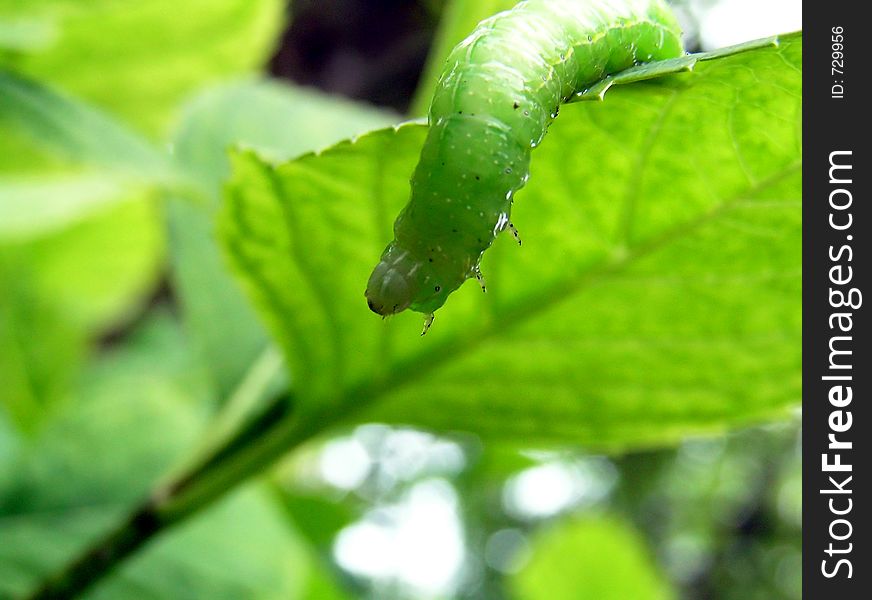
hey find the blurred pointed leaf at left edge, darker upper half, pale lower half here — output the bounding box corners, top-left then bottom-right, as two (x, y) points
(0, 70), (180, 246)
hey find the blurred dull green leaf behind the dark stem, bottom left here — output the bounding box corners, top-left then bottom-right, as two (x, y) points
(0, 318), (324, 599)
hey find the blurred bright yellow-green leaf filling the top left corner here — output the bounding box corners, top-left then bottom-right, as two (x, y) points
(0, 0), (285, 134)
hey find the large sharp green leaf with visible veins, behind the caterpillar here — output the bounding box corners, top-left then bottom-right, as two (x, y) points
(221, 36), (802, 449)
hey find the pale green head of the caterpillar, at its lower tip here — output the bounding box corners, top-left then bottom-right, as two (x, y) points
(366, 244), (447, 317)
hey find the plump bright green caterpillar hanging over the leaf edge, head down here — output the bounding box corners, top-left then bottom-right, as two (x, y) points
(366, 0), (683, 335)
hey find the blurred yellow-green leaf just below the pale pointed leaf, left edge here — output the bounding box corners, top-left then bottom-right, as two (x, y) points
(0, 196), (163, 432)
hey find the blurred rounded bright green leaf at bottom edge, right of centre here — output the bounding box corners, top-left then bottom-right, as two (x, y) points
(510, 517), (675, 600)
